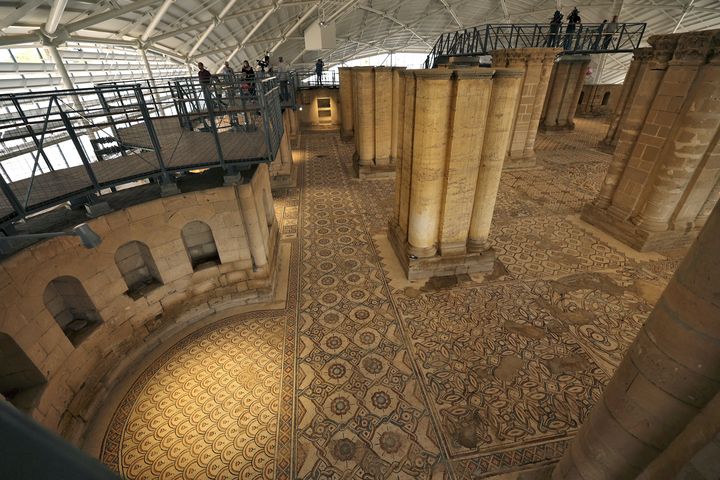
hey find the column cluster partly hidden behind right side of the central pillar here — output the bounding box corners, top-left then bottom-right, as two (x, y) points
(491, 48), (560, 169)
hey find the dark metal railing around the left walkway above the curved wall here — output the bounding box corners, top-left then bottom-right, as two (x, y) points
(0, 76), (292, 229)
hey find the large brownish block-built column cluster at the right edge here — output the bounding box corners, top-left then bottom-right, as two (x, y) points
(583, 30), (720, 250)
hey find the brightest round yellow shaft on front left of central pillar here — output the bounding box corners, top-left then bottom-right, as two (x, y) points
(408, 69), (453, 258)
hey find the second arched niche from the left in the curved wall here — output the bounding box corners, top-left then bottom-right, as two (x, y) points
(43, 276), (102, 346)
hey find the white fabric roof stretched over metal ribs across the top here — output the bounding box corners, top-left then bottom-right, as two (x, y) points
(0, 0), (720, 83)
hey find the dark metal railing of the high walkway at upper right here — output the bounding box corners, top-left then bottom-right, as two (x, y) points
(425, 23), (645, 68)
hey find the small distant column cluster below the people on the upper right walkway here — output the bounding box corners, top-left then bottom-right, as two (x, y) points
(540, 55), (590, 131)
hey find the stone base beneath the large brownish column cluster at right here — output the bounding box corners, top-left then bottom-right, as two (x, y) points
(580, 204), (700, 252)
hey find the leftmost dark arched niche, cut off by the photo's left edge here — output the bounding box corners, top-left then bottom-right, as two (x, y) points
(0, 332), (46, 408)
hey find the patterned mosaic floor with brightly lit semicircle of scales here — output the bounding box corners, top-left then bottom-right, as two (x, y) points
(102, 119), (678, 480)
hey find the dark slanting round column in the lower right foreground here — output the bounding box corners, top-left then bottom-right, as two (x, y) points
(552, 200), (720, 480)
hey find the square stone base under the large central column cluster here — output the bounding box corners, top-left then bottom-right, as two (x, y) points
(388, 221), (495, 280)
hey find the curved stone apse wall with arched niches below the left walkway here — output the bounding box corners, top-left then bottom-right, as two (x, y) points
(0, 165), (278, 440)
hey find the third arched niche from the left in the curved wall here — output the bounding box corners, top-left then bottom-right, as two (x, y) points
(115, 240), (162, 299)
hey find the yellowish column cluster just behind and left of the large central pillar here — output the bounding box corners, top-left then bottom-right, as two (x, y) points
(340, 67), (404, 178)
